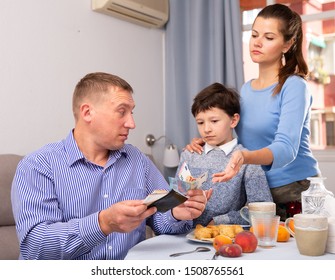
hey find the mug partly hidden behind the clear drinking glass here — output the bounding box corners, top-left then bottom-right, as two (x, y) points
(240, 201), (276, 224)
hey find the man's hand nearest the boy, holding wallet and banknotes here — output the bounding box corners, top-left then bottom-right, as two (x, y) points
(172, 189), (213, 220)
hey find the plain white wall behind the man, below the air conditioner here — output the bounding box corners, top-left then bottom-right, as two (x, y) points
(0, 0), (164, 158)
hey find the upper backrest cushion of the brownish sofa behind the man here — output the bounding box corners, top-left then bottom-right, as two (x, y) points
(0, 154), (23, 226)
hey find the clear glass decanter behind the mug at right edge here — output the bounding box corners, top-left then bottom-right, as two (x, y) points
(301, 177), (334, 217)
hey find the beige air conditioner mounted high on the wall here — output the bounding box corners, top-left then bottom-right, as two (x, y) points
(92, 0), (169, 28)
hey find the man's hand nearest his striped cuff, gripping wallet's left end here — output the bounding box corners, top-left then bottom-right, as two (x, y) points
(99, 200), (157, 235)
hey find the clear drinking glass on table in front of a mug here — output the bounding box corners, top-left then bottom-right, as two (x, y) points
(250, 215), (280, 247)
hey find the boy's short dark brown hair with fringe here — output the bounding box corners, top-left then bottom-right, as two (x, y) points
(191, 83), (241, 117)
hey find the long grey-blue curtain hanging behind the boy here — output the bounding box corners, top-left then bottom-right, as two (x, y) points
(165, 0), (244, 149)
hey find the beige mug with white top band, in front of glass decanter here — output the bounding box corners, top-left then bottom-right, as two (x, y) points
(285, 214), (328, 256)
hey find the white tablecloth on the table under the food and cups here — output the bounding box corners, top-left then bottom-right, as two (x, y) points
(126, 234), (335, 260)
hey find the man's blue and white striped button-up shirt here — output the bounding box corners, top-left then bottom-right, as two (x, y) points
(12, 132), (193, 259)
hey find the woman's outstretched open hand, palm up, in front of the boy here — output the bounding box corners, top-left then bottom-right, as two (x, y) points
(212, 150), (244, 183)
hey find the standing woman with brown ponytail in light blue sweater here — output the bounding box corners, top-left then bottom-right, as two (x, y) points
(187, 4), (320, 220)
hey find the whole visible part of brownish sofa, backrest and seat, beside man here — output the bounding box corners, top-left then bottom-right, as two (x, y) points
(0, 154), (23, 260)
